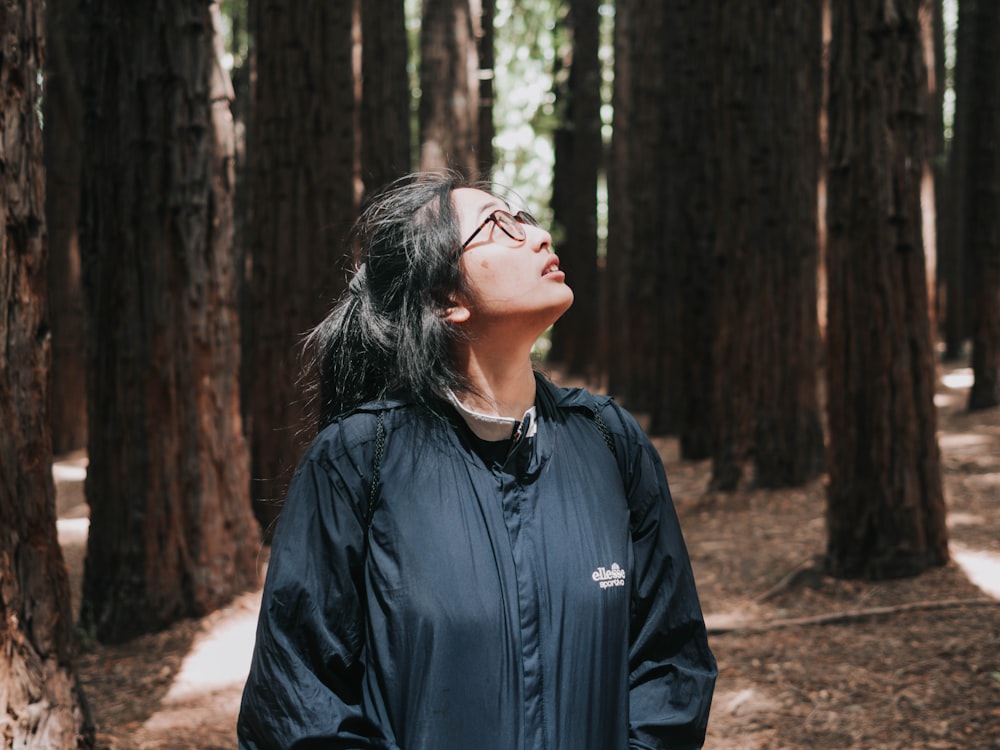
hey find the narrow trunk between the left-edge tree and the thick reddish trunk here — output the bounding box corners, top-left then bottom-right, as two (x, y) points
(42, 0), (87, 454)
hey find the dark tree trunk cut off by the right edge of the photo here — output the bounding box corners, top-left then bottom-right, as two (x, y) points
(963, 0), (1000, 409)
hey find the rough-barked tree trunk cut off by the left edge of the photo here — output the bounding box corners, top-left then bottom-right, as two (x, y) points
(0, 0), (94, 748)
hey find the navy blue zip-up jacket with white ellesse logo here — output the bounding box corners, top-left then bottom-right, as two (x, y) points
(238, 378), (717, 750)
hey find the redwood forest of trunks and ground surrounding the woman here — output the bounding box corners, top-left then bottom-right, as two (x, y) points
(0, 0), (1000, 748)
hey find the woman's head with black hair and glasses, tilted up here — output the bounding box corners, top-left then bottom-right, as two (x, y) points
(307, 173), (572, 428)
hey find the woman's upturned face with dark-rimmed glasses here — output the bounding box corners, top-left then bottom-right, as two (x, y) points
(452, 188), (573, 336)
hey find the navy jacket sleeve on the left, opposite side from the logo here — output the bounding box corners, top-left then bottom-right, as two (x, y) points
(237, 424), (396, 750)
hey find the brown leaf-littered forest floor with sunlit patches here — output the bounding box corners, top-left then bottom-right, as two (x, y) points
(54, 368), (1000, 750)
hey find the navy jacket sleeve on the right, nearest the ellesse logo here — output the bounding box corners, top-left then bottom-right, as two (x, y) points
(605, 406), (718, 750)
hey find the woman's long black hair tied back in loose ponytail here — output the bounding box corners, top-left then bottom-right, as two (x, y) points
(305, 172), (478, 429)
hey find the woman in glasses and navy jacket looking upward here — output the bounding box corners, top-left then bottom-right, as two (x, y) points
(239, 175), (716, 750)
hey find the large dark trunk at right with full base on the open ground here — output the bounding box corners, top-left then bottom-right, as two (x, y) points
(827, 0), (948, 579)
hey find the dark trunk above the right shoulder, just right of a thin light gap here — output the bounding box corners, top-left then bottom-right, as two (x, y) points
(607, 0), (682, 433)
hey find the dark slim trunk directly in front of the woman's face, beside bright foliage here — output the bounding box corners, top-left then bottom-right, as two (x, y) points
(551, 0), (603, 382)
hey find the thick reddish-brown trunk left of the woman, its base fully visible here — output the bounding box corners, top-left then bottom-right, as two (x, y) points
(81, 0), (259, 641)
